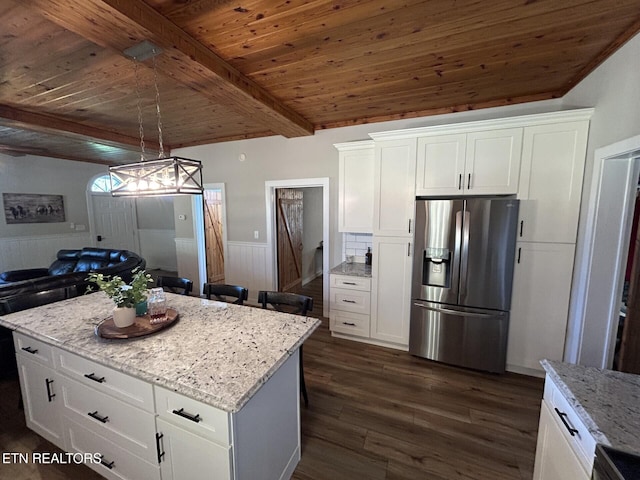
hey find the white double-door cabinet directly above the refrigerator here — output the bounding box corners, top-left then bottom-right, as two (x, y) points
(416, 128), (522, 196)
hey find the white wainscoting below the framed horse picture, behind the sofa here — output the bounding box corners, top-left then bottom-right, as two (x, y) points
(0, 232), (92, 272)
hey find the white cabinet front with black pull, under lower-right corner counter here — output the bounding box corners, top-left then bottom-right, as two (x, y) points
(533, 376), (596, 480)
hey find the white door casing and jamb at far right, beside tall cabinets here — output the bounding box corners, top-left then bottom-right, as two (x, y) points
(564, 136), (640, 369)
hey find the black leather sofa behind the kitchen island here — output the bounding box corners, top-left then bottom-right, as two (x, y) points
(0, 247), (146, 315)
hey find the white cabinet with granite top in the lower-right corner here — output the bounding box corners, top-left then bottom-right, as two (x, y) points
(533, 360), (640, 480)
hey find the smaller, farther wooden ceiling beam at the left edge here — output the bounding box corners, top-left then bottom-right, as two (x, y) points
(0, 105), (162, 153)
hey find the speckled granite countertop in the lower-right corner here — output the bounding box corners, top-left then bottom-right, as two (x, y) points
(541, 360), (640, 453)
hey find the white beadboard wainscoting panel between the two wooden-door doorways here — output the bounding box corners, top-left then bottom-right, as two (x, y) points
(225, 242), (273, 303)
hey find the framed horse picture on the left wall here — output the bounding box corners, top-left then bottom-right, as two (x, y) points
(2, 193), (65, 224)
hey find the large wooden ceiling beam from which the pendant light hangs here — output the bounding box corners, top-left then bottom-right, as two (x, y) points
(25, 0), (314, 137)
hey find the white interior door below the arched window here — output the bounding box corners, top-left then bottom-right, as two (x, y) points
(91, 195), (140, 253)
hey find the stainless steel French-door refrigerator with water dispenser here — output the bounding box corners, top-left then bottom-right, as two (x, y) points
(409, 197), (518, 373)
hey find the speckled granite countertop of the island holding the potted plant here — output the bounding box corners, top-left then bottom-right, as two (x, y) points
(0, 292), (320, 412)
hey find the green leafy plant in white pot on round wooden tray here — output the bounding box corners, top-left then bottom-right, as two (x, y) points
(87, 269), (153, 328)
